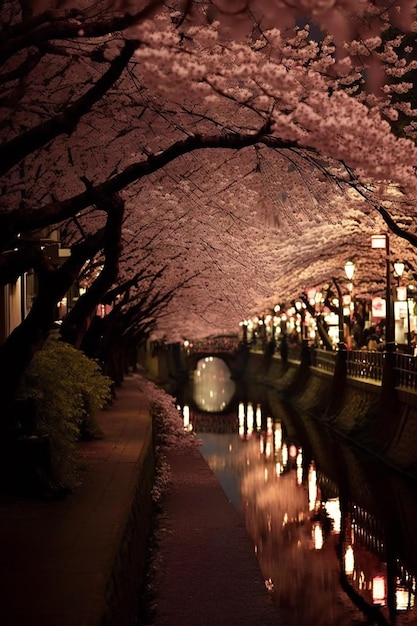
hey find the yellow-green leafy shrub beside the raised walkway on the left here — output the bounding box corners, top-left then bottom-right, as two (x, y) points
(16, 335), (112, 488)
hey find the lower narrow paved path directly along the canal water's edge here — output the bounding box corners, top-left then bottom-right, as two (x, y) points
(145, 448), (282, 626)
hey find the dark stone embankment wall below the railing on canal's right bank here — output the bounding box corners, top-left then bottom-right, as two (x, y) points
(244, 353), (417, 478)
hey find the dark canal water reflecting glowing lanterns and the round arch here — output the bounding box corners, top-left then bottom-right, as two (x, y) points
(178, 357), (417, 626)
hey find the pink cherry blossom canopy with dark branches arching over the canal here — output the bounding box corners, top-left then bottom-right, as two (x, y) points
(0, 1), (417, 428)
